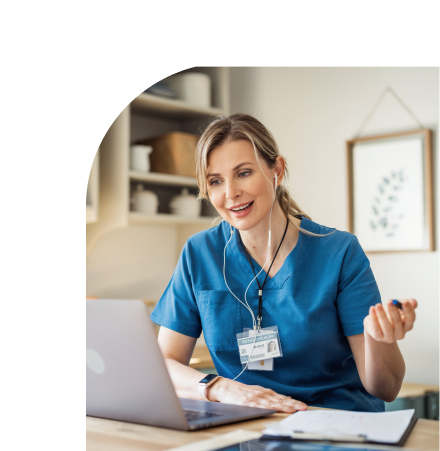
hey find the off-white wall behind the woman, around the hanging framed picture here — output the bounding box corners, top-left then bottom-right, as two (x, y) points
(231, 66), (440, 384)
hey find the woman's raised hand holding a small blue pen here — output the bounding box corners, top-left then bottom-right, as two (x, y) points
(364, 299), (417, 343)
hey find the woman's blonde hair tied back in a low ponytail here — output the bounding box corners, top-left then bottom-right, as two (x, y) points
(195, 113), (330, 236)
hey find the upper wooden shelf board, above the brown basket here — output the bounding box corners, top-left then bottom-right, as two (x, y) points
(131, 92), (223, 119)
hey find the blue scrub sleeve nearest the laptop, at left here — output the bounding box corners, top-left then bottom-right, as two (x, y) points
(151, 242), (202, 338)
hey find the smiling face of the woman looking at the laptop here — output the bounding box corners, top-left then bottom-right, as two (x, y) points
(207, 139), (275, 230)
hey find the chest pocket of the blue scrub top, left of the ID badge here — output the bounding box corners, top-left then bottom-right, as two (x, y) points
(195, 290), (241, 352)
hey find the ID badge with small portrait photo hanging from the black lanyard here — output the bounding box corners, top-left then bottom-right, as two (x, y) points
(237, 326), (283, 371)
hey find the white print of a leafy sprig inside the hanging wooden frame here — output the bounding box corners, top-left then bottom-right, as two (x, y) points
(353, 137), (427, 251)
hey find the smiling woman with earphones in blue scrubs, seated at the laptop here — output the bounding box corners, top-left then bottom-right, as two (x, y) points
(151, 114), (417, 413)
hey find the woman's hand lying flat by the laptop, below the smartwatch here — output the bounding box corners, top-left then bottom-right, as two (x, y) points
(206, 377), (307, 413)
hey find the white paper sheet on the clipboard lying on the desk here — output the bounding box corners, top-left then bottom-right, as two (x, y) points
(263, 409), (414, 443)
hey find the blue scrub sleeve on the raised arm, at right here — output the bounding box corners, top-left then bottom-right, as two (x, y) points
(336, 236), (381, 336)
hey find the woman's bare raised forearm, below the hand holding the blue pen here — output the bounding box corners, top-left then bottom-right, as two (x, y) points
(364, 333), (405, 402)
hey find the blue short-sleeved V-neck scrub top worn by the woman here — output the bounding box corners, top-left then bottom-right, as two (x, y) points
(151, 217), (385, 412)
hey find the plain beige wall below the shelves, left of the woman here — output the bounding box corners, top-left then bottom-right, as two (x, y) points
(86, 224), (210, 301)
